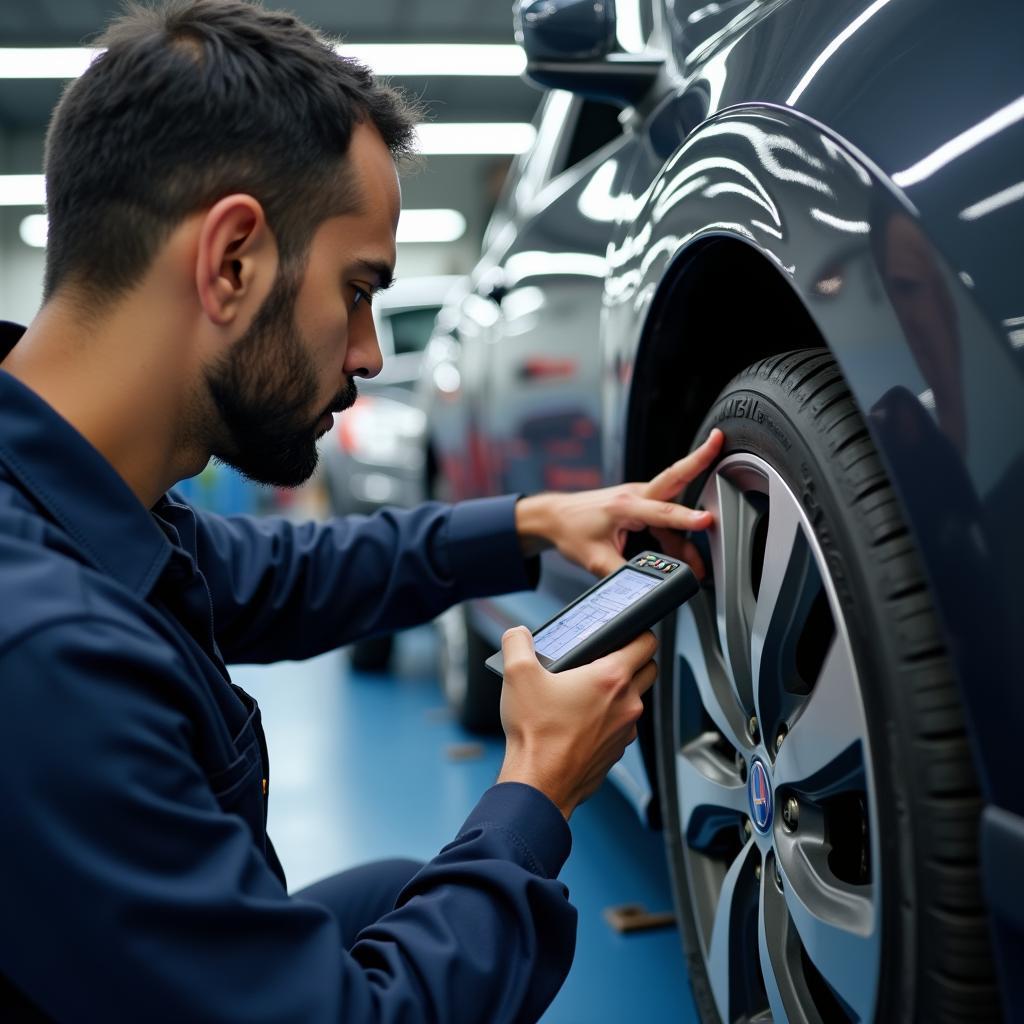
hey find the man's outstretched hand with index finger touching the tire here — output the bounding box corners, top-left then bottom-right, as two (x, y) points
(516, 428), (725, 578)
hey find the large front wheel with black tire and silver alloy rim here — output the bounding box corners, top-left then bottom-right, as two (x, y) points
(655, 349), (999, 1024)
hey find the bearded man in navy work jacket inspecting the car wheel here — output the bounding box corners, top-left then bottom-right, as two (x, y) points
(0, 0), (721, 1024)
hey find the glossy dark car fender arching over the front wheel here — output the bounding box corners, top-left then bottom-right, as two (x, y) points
(602, 104), (1024, 831)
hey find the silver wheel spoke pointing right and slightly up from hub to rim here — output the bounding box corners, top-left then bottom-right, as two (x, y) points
(774, 633), (866, 797)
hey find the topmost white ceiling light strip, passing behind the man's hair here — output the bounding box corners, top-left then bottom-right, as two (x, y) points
(0, 43), (526, 79)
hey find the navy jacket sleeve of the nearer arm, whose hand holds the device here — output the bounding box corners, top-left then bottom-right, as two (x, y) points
(0, 620), (575, 1024)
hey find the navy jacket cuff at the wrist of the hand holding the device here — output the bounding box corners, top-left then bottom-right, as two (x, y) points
(459, 782), (572, 879)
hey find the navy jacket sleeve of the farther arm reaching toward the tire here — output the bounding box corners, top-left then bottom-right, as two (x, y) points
(186, 497), (539, 663)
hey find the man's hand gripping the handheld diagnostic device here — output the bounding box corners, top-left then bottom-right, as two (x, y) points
(498, 626), (657, 820)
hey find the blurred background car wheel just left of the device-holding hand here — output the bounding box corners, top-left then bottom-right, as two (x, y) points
(437, 605), (502, 735)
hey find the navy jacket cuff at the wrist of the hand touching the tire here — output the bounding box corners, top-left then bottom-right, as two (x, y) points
(447, 495), (541, 600)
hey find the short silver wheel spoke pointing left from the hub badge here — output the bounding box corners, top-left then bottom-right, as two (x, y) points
(676, 732), (746, 850)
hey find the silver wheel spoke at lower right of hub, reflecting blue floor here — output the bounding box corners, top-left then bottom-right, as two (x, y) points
(778, 839), (881, 1021)
